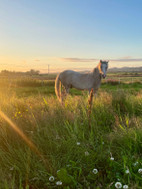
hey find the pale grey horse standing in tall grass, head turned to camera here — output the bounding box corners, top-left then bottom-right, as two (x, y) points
(55, 60), (108, 101)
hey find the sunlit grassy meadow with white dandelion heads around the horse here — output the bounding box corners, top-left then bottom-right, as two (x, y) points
(0, 74), (142, 189)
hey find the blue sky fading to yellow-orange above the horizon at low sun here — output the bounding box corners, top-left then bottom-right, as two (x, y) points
(0, 0), (142, 73)
